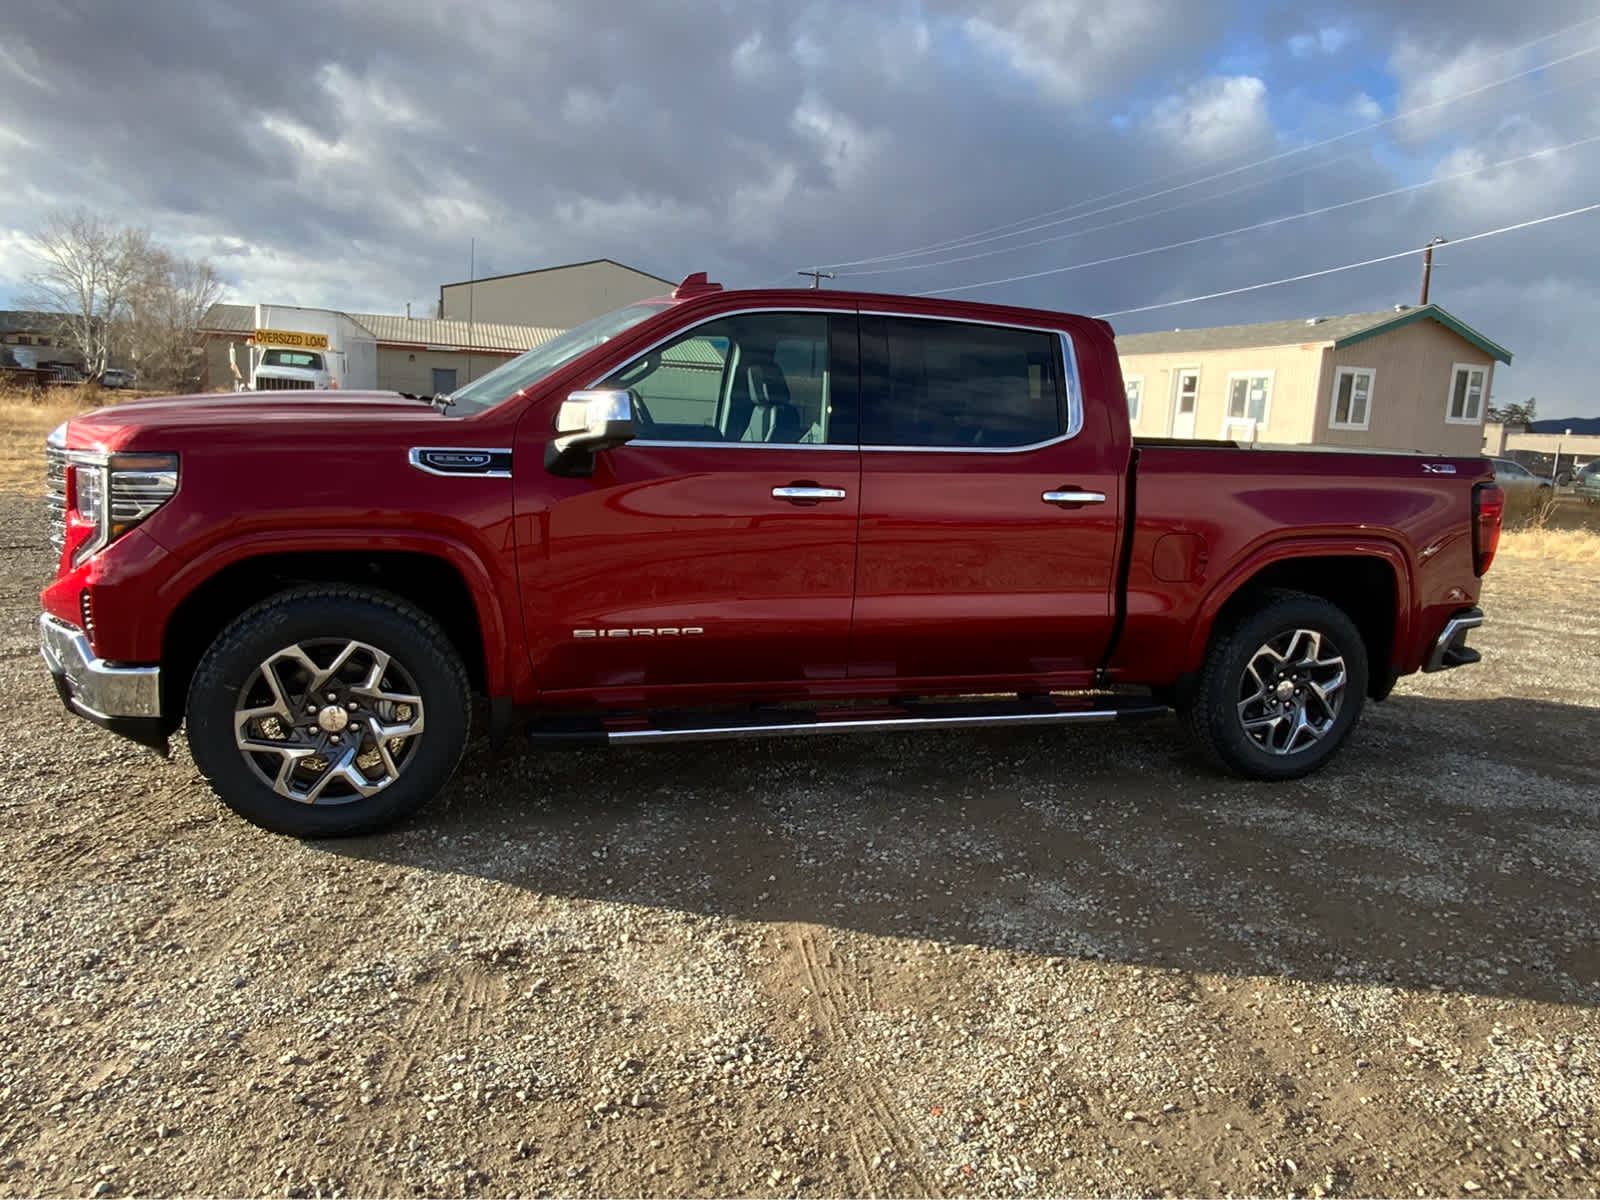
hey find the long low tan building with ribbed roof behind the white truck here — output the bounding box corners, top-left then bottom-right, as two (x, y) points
(200, 304), (560, 395)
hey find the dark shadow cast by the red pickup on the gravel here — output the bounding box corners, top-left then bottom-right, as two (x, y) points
(323, 696), (1600, 1006)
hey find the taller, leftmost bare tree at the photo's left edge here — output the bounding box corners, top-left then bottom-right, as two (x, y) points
(22, 208), (152, 378)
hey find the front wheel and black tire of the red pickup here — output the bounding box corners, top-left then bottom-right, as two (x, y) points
(186, 586), (472, 838)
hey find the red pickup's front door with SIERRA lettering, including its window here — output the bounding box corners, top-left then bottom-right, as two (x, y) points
(517, 312), (861, 702)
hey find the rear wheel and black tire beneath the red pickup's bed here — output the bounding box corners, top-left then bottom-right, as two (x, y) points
(1179, 592), (1368, 779)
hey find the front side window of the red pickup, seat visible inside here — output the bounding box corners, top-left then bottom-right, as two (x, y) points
(600, 312), (854, 445)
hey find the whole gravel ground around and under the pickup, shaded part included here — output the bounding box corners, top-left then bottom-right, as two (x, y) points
(0, 496), (1600, 1197)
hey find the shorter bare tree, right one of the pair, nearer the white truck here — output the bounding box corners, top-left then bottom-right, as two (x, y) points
(123, 250), (222, 389)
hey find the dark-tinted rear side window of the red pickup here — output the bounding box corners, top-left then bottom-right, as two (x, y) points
(861, 317), (1067, 450)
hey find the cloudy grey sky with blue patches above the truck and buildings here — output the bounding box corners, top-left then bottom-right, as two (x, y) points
(9, 0), (1600, 416)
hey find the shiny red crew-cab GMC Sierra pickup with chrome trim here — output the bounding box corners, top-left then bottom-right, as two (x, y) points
(40, 275), (1502, 837)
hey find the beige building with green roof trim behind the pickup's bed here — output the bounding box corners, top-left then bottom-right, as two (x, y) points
(1117, 304), (1510, 454)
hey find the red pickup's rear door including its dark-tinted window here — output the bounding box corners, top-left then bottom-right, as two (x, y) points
(850, 315), (1125, 685)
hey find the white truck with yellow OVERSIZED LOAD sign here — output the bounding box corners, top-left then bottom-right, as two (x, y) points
(248, 304), (378, 392)
